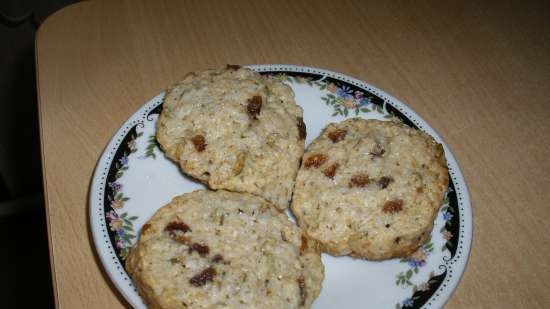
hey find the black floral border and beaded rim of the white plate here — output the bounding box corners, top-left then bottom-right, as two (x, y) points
(89, 65), (472, 309)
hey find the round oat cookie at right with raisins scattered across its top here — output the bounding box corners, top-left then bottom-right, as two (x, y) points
(291, 118), (449, 260)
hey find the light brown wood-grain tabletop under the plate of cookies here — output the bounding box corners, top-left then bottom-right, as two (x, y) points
(36, 0), (550, 309)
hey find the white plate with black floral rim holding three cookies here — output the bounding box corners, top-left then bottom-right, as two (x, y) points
(89, 65), (472, 309)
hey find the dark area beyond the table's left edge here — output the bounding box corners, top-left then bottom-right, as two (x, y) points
(0, 0), (78, 308)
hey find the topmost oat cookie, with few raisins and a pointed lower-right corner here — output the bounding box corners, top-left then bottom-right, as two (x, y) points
(156, 66), (306, 209)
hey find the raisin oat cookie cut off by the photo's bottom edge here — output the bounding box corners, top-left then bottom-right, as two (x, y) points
(126, 190), (324, 309)
